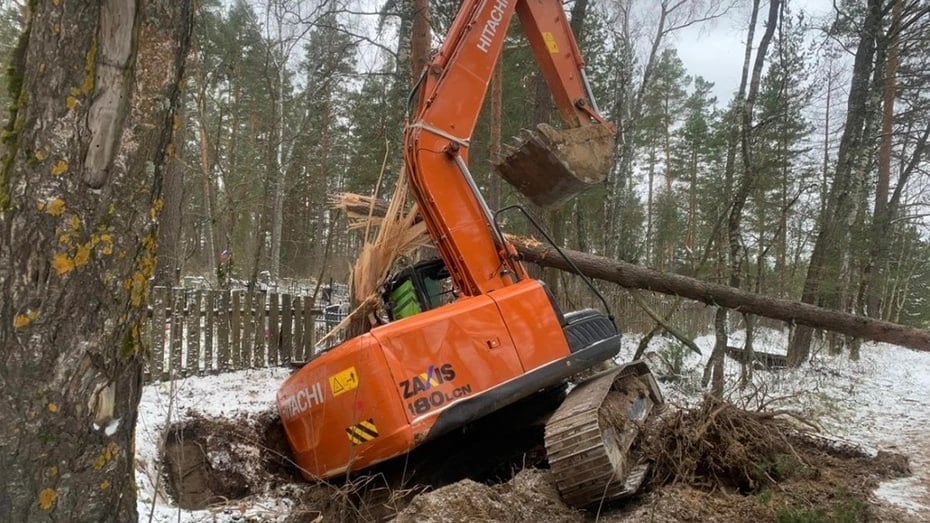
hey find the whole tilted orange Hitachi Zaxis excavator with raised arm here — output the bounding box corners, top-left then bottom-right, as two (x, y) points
(277, 0), (662, 506)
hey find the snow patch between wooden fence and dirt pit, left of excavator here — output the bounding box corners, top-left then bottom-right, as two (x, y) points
(136, 368), (291, 522)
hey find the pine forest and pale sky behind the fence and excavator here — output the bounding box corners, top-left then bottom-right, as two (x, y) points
(0, 0), (930, 352)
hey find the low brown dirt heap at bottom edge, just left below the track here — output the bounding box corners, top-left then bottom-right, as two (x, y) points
(397, 469), (584, 523)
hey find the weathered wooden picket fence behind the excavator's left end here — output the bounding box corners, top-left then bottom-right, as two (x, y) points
(146, 287), (341, 381)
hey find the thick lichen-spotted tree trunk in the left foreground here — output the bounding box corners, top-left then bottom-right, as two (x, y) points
(0, 0), (192, 521)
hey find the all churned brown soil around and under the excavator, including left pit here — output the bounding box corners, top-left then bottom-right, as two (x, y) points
(161, 404), (919, 522)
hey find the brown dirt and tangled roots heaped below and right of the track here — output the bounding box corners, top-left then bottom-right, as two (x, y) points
(398, 401), (913, 522)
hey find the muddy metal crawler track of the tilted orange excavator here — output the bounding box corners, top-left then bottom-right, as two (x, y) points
(545, 362), (662, 507)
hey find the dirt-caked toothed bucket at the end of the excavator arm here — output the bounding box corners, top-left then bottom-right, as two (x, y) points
(495, 124), (614, 207)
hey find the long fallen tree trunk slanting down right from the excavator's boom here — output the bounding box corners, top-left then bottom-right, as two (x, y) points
(508, 237), (930, 352)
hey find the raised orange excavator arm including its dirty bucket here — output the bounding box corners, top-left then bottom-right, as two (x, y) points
(404, 0), (614, 296)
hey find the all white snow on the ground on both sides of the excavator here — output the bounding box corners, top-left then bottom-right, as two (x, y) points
(136, 329), (930, 522)
